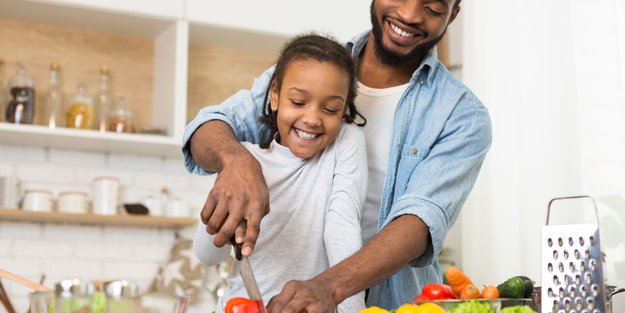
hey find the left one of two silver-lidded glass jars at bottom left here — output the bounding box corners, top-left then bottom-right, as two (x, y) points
(54, 279), (94, 312)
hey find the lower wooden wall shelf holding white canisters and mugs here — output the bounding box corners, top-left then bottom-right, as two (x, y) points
(0, 209), (197, 229)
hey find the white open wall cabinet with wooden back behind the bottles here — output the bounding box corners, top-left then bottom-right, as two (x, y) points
(0, 0), (287, 156)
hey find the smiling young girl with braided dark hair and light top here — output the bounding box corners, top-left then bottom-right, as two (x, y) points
(194, 35), (367, 313)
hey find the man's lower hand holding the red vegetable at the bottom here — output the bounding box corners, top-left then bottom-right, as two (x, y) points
(267, 279), (337, 313)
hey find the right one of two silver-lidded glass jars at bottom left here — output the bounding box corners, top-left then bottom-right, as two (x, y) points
(104, 280), (141, 313)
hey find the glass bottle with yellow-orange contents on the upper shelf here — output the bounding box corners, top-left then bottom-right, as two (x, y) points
(65, 84), (95, 129)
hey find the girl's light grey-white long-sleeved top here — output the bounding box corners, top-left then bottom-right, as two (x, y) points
(194, 124), (367, 313)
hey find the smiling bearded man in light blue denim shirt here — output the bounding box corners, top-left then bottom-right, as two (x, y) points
(184, 0), (491, 312)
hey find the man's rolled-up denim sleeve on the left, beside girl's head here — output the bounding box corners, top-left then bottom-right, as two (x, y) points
(182, 66), (274, 175)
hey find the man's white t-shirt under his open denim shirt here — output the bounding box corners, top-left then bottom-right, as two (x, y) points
(355, 82), (408, 243)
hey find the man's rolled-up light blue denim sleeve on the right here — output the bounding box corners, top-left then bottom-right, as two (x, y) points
(381, 105), (492, 267)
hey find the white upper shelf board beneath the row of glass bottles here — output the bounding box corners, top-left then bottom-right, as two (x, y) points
(0, 123), (181, 156)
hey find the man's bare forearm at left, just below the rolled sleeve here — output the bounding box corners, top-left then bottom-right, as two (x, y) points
(189, 120), (249, 172)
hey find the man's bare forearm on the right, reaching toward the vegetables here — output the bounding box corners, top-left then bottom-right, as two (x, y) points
(313, 215), (429, 303)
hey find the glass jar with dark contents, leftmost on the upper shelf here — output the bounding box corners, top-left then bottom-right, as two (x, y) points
(5, 65), (35, 124)
